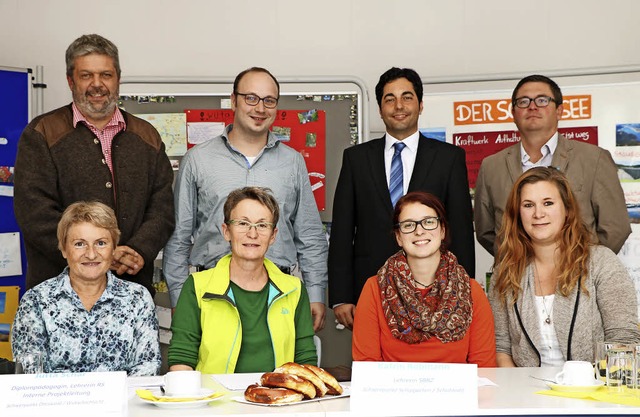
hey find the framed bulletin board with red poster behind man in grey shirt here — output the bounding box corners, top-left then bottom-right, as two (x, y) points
(120, 78), (368, 222)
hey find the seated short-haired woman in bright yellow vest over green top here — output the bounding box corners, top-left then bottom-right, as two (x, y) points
(169, 187), (317, 373)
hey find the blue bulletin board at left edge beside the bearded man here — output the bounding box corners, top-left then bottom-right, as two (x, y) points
(0, 67), (31, 291)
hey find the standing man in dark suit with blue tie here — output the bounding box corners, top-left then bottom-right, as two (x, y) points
(329, 68), (475, 329)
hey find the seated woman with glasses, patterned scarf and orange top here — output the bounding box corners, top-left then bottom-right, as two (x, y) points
(352, 191), (496, 367)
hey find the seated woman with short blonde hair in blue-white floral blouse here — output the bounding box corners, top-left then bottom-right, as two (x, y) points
(11, 202), (161, 375)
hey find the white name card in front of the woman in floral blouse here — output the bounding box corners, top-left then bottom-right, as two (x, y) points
(0, 372), (127, 417)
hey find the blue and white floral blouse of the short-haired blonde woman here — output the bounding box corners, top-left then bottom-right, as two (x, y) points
(11, 268), (161, 375)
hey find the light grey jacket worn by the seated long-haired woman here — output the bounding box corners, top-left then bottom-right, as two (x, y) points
(489, 245), (640, 366)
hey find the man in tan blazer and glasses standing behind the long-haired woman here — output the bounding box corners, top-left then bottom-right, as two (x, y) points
(474, 75), (631, 255)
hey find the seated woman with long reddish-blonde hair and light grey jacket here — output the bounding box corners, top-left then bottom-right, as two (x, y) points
(489, 167), (640, 366)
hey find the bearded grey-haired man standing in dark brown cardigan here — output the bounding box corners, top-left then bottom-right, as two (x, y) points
(14, 34), (174, 295)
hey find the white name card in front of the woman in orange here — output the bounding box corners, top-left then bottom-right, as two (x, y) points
(351, 362), (478, 416)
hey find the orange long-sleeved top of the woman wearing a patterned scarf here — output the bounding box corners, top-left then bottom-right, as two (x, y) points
(351, 276), (496, 367)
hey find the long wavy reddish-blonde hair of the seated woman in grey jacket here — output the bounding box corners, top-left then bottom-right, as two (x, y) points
(493, 167), (594, 304)
